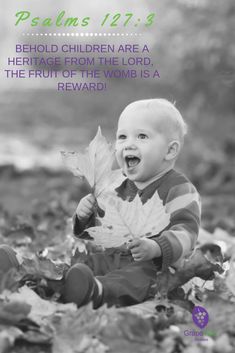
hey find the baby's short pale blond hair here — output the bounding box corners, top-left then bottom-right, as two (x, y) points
(124, 98), (187, 147)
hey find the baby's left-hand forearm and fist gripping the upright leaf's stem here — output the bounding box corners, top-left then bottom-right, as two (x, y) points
(73, 194), (96, 236)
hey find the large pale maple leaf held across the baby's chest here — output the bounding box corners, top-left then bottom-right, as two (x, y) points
(86, 192), (170, 248)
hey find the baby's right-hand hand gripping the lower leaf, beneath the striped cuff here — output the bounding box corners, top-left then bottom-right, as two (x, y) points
(128, 238), (161, 261)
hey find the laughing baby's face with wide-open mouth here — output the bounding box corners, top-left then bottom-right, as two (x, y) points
(116, 107), (168, 182)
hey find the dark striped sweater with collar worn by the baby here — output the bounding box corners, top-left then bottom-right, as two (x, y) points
(74, 169), (201, 269)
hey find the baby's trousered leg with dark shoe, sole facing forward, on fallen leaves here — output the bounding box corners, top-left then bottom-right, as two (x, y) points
(63, 261), (157, 308)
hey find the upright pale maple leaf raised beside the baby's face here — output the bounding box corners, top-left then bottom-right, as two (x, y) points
(61, 127), (120, 197)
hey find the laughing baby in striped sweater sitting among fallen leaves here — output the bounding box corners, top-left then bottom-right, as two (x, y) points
(0, 99), (200, 308)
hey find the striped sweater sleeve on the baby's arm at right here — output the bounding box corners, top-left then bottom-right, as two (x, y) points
(152, 182), (201, 269)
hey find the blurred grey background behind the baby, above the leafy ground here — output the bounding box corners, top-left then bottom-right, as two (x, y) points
(0, 0), (235, 241)
